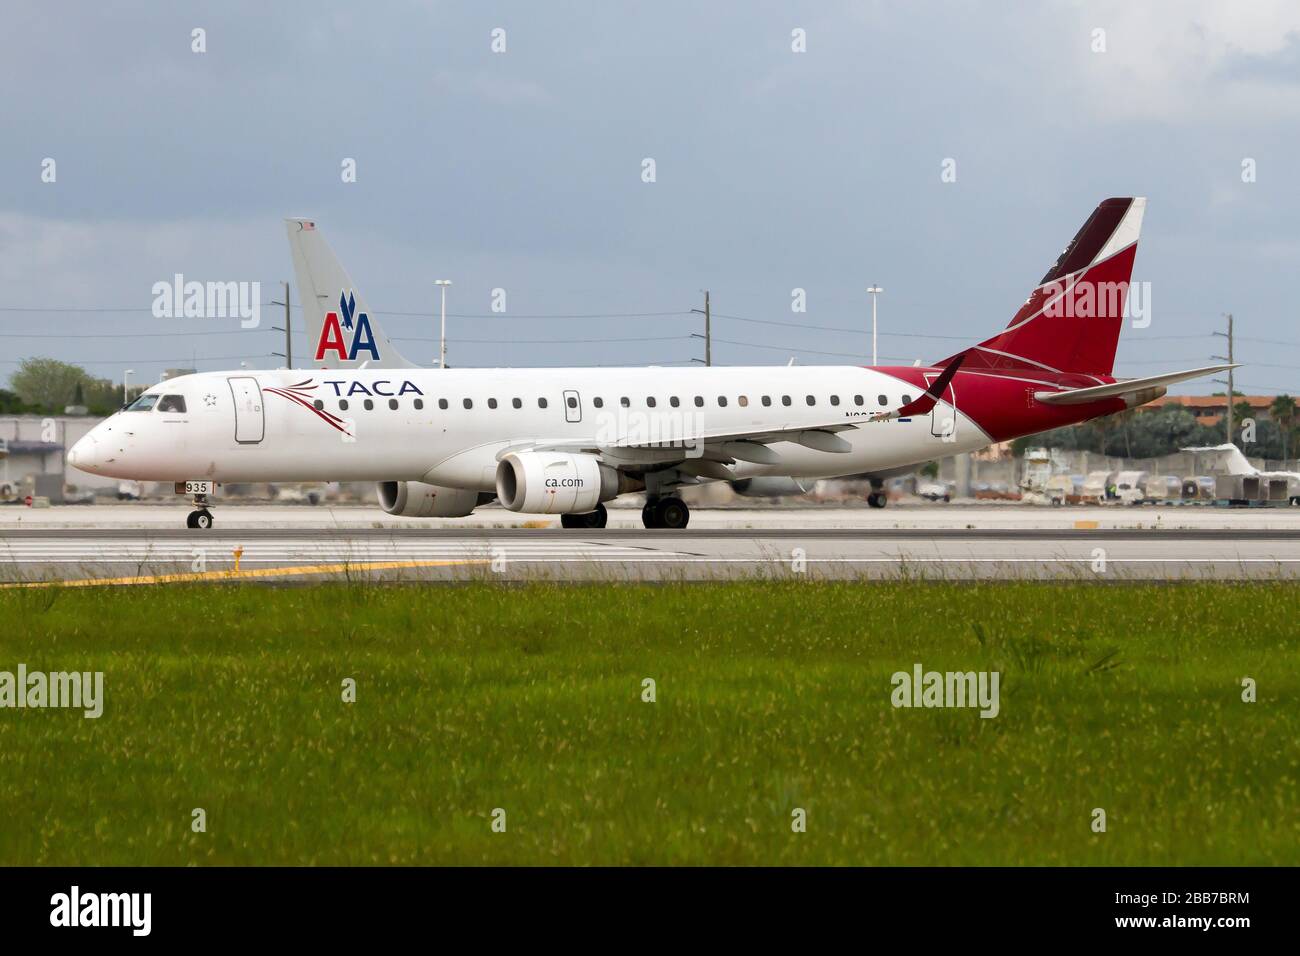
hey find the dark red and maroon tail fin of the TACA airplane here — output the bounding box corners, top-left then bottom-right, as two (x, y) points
(937, 198), (1147, 376)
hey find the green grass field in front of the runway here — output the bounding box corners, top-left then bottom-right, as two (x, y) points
(0, 581), (1300, 865)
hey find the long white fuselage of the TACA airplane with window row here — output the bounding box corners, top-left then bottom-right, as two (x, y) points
(61, 365), (1114, 492)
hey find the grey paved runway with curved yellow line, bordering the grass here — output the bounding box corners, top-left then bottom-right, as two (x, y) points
(0, 515), (1300, 587)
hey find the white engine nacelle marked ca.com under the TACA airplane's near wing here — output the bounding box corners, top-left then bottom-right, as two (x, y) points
(497, 451), (627, 515)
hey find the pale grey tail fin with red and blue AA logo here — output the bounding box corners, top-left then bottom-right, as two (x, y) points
(285, 219), (416, 368)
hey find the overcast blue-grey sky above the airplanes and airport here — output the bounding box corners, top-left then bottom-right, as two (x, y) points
(0, 0), (1300, 393)
